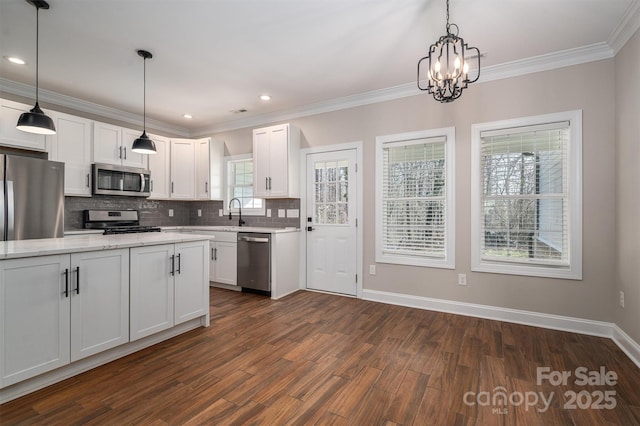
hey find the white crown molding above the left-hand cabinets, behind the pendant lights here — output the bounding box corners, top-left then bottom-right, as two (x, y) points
(0, 78), (190, 137)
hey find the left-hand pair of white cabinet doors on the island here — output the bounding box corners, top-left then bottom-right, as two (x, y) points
(0, 249), (129, 387)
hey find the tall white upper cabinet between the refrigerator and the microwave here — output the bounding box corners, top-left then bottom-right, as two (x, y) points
(47, 112), (93, 197)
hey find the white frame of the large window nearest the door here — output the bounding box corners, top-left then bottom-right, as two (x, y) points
(375, 127), (456, 269)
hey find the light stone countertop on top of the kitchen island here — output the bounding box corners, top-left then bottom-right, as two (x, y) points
(0, 232), (209, 259)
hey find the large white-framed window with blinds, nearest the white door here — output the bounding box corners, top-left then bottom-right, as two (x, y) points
(376, 128), (453, 266)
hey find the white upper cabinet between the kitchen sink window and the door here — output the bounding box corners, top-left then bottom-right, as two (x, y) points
(253, 124), (300, 198)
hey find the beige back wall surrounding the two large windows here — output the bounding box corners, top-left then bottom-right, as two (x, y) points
(215, 59), (620, 322)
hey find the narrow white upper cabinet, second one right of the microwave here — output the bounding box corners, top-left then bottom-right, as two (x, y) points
(170, 139), (196, 200)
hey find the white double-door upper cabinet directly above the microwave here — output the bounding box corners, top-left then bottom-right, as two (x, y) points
(93, 121), (148, 169)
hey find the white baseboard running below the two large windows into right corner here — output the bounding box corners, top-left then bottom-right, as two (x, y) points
(362, 289), (640, 367)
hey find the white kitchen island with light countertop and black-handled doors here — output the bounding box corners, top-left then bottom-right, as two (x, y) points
(0, 232), (210, 403)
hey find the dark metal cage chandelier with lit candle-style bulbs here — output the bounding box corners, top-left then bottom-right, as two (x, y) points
(418, 0), (480, 103)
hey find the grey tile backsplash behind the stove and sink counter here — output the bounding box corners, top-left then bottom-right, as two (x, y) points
(64, 195), (300, 231)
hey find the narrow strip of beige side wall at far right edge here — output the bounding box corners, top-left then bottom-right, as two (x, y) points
(612, 29), (640, 342)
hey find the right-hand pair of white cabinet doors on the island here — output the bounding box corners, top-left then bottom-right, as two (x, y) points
(130, 241), (209, 341)
